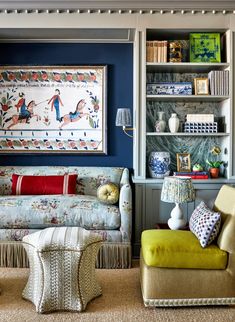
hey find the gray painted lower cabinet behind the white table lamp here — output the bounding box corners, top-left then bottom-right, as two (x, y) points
(133, 180), (230, 257)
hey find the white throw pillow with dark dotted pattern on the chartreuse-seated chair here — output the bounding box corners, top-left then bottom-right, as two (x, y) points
(189, 201), (221, 248)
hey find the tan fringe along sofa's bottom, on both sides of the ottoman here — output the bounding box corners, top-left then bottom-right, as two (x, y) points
(0, 241), (131, 268)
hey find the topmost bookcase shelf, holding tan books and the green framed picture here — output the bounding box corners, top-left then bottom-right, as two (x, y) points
(146, 62), (229, 73)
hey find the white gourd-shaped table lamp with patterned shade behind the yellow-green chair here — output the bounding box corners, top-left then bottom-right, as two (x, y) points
(161, 177), (195, 230)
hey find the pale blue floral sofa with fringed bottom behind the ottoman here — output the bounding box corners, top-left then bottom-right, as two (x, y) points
(0, 166), (132, 268)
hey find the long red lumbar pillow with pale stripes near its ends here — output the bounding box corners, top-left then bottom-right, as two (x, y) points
(12, 174), (77, 195)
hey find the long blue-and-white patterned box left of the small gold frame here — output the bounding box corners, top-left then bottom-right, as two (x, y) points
(147, 82), (192, 95)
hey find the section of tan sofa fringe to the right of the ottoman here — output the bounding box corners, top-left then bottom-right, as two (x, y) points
(96, 243), (131, 268)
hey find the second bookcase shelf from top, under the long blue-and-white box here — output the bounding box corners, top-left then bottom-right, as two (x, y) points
(146, 95), (229, 102)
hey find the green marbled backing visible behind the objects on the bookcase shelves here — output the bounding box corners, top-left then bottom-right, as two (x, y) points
(146, 73), (226, 171)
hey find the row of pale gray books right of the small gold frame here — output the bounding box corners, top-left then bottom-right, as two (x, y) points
(208, 70), (229, 96)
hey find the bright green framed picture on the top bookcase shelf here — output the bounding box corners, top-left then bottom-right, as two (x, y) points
(190, 33), (221, 63)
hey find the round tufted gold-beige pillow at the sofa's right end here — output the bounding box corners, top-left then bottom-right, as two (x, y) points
(97, 182), (119, 205)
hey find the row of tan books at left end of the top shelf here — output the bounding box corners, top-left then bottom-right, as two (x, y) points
(146, 40), (167, 63)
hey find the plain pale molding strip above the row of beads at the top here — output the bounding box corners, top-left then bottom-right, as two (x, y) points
(0, 0), (235, 11)
